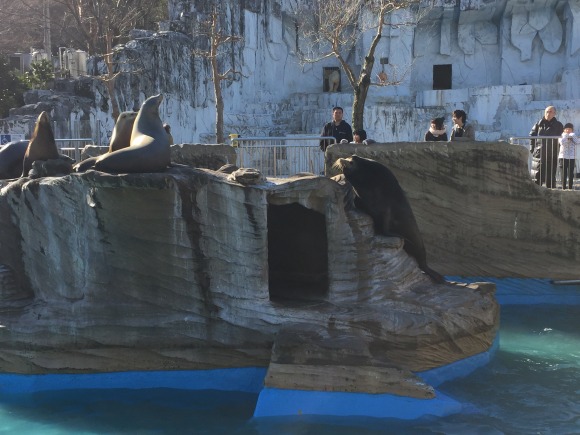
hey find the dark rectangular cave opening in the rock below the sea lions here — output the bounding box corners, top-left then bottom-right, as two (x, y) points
(268, 203), (328, 300)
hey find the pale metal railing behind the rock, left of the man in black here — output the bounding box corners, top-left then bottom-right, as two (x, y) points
(230, 135), (336, 178)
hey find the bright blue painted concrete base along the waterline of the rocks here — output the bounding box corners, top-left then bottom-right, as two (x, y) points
(0, 277), (568, 420)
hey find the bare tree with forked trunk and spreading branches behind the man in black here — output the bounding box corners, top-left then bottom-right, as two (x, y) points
(295, 0), (420, 129)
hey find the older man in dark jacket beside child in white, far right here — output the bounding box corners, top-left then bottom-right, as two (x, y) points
(530, 106), (564, 188)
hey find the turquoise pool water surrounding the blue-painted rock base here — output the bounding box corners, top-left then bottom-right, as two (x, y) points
(0, 305), (580, 435)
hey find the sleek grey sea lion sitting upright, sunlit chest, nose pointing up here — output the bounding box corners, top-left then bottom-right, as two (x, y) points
(95, 94), (171, 174)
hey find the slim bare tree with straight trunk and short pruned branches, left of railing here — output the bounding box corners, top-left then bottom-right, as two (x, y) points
(194, 4), (243, 143)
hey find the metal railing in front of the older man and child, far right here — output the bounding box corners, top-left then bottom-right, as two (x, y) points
(509, 136), (580, 189)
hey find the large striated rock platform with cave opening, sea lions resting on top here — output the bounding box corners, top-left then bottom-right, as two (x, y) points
(0, 151), (498, 397)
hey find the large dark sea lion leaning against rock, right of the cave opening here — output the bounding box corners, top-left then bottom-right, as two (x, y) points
(334, 155), (445, 283)
